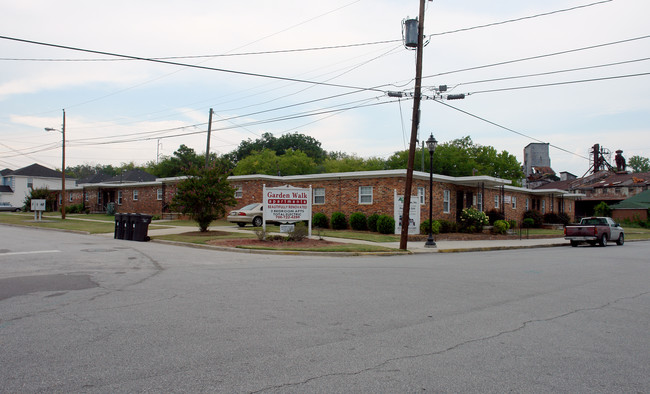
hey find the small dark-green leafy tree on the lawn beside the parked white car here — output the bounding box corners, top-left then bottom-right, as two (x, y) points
(171, 161), (237, 232)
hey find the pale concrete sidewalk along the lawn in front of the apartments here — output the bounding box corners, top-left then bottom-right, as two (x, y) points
(140, 223), (569, 254)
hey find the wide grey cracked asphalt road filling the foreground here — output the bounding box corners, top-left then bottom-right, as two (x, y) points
(0, 225), (650, 393)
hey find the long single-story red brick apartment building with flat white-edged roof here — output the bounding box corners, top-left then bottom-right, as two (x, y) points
(60, 170), (582, 225)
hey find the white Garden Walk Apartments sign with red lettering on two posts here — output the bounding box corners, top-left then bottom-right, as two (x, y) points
(262, 185), (312, 237)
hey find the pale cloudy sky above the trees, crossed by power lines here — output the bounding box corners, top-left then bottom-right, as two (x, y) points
(0, 0), (650, 176)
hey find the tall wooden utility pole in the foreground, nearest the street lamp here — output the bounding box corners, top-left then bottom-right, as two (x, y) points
(399, 0), (425, 250)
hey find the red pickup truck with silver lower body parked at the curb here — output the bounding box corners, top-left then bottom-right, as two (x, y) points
(564, 217), (625, 247)
